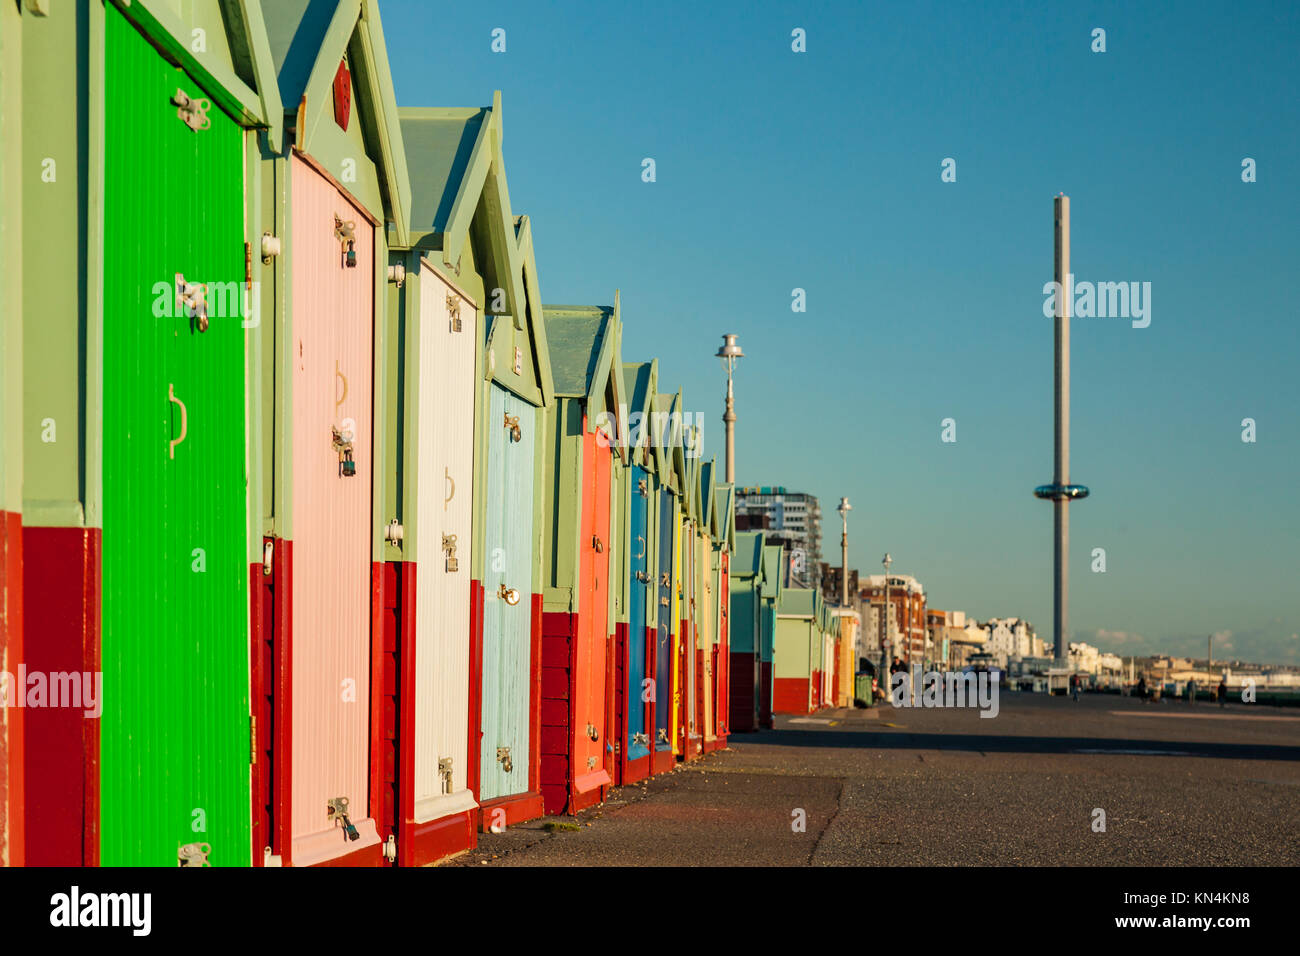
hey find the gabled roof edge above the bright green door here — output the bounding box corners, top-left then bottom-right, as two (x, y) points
(114, 0), (283, 143)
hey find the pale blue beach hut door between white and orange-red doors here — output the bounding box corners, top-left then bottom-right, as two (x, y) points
(478, 382), (538, 803)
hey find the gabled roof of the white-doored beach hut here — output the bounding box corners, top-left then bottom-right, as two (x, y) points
(398, 90), (522, 323)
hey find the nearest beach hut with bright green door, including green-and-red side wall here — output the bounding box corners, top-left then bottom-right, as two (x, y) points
(15, 0), (281, 866)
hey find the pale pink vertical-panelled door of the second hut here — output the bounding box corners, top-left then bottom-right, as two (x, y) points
(290, 155), (377, 862)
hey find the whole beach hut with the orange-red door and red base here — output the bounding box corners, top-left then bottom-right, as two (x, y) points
(541, 297), (627, 814)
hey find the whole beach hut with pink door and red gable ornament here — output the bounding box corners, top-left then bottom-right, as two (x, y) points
(252, 0), (411, 866)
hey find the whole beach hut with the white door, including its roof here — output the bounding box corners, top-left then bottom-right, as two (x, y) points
(385, 96), (530, 865)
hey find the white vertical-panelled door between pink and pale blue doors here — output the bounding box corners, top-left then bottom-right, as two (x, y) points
(415, 265), (478, 822)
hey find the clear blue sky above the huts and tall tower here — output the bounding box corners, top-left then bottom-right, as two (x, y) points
(380, 0), (1300, 663)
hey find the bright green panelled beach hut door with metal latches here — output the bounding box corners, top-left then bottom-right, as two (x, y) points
(100, 4), (250, 866)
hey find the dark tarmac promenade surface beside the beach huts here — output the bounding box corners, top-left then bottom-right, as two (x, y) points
(443, 692), (1300, 866)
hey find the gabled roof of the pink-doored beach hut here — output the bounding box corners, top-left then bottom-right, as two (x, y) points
(263, 0), (411, 246)
